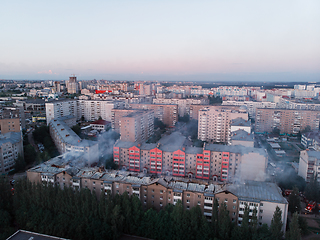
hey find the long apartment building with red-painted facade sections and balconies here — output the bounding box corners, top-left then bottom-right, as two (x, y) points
(113, 132), (268, 181)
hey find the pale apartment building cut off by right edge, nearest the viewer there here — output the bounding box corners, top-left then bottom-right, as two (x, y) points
(298, 149), (320, 182)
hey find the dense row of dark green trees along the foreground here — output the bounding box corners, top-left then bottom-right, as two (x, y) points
(0, 178), (300, 240)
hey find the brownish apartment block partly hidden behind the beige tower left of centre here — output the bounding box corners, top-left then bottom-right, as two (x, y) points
(130, 103), (179, 127)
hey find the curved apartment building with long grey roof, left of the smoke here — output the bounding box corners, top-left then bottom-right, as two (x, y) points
(49, 115), (99, 166)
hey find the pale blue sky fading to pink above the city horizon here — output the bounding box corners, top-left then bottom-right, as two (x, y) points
(0, 0), (320, 82)
